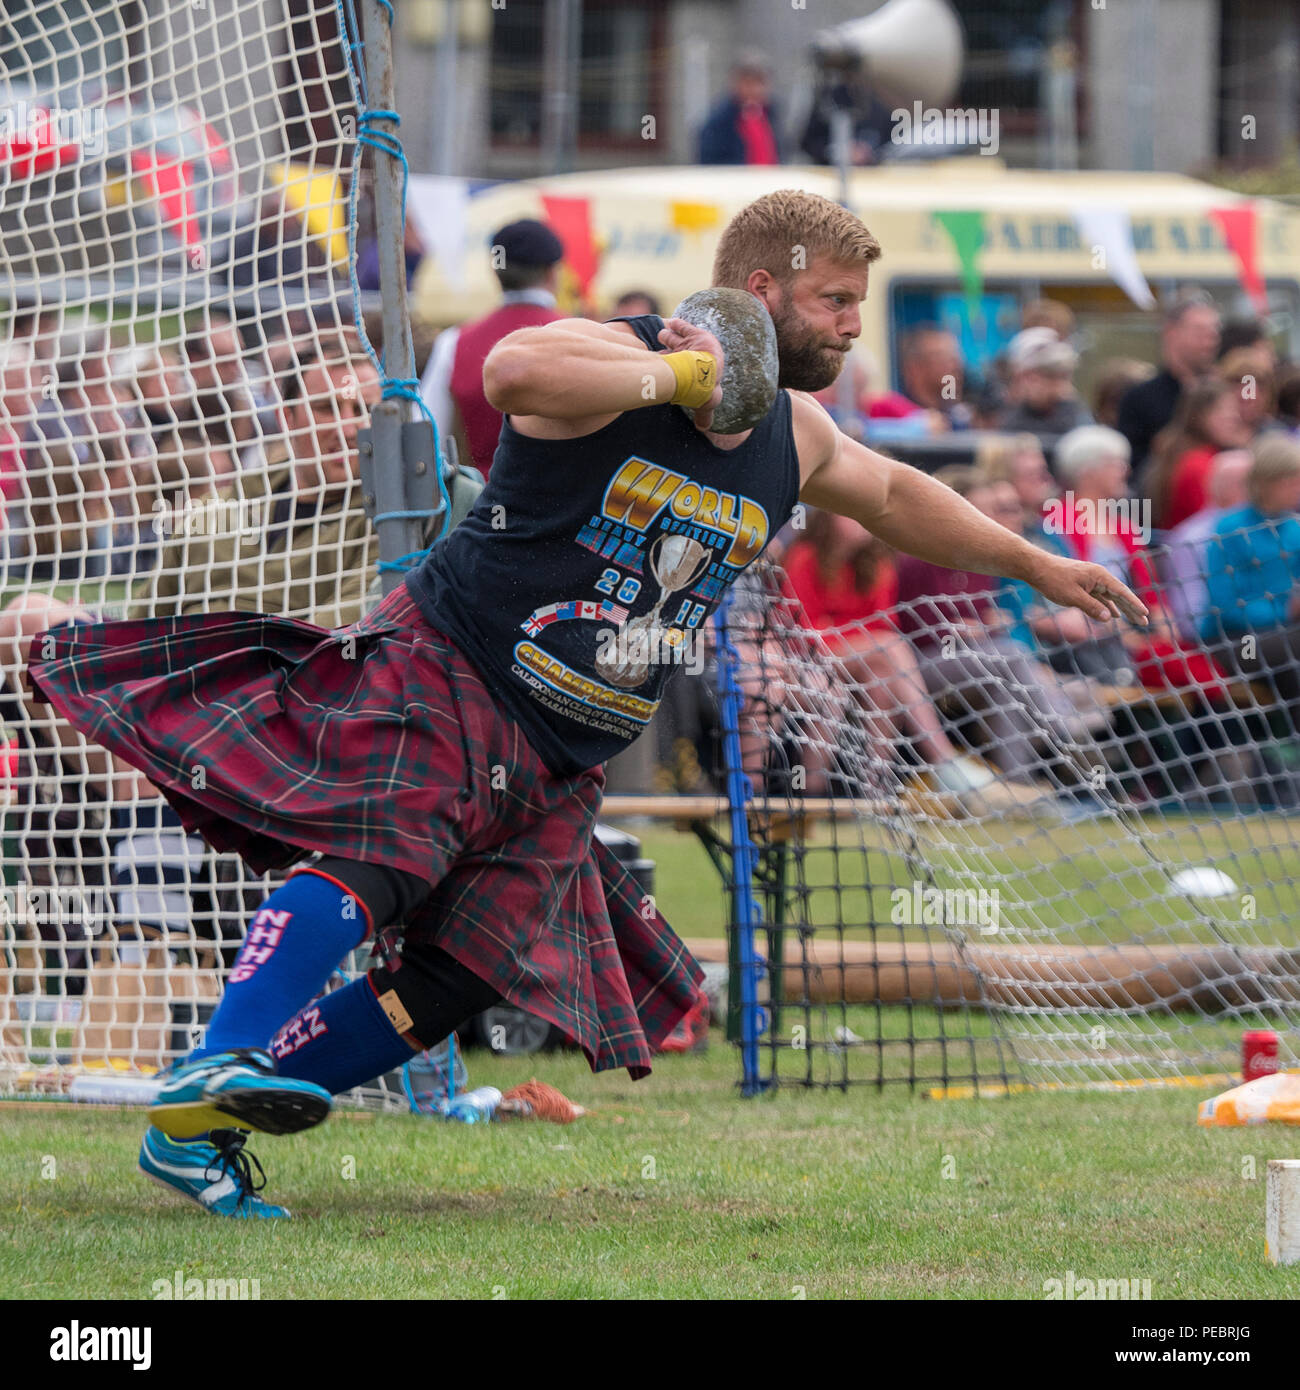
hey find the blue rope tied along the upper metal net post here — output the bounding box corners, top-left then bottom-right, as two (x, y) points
(336, 0), (452, 574)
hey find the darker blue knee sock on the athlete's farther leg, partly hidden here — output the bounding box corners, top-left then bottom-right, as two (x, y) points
(271, 977), (419, 1095)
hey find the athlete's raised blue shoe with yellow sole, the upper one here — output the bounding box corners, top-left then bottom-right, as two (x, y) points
(149, 1048), (330, 1138)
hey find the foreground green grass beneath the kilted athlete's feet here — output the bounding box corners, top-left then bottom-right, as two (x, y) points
(0, 1050), (1300, 1298)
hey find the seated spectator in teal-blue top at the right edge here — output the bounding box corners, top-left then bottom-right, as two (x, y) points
(1201, 434), (1300, 731)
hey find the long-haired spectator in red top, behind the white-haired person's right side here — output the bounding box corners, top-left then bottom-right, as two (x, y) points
(1139, 379), (1250, 531)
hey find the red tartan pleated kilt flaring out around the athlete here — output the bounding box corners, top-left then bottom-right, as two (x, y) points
(29, 587), (701, 1076)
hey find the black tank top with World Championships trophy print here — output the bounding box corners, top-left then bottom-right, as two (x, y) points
(406, 314), (799, 777)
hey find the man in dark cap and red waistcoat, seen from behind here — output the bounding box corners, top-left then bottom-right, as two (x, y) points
(420, 217), (564, 477)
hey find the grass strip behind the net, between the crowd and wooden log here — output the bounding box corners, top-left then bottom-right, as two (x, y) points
(628, 815), (1300, 947)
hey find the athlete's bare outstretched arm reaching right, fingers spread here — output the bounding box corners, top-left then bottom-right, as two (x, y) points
(794, 393), (1147, 623)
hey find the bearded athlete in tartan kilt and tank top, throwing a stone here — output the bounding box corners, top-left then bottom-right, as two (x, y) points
(31, 192), (1144, 1216)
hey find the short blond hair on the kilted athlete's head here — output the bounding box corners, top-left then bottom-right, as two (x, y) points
(713, 188), (880, 289)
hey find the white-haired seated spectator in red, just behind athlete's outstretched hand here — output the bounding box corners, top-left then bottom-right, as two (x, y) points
(1047, 425), (1226, 703)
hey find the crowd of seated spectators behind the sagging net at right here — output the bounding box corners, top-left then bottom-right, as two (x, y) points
(761, 288), (1300, 813)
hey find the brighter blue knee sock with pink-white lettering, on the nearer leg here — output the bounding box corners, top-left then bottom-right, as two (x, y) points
(198, 872), (367, 1058)
